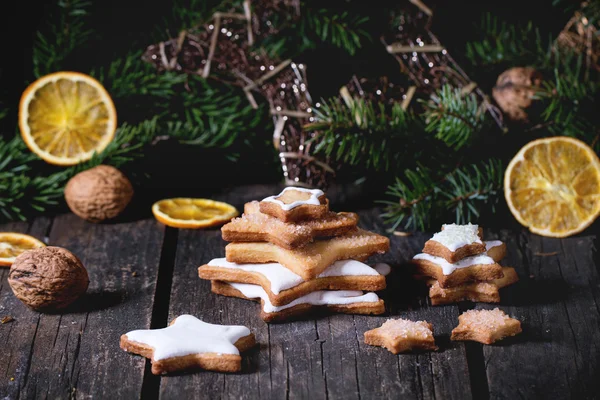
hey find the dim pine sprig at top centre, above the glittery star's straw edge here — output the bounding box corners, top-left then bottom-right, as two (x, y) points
(259, 7), (370, 59)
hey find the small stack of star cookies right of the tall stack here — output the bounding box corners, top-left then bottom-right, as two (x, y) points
(412, 224), (519, 305)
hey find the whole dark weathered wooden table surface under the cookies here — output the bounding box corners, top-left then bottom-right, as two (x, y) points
(0, 186), (600, 399)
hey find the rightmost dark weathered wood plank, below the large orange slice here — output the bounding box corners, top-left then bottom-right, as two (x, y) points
(478, 232), (600, 399)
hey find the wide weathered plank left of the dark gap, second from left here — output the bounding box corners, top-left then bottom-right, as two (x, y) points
(12, 214), (164, 398)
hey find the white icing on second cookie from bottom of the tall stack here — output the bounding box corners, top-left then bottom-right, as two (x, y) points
(208, 258), (383, 294)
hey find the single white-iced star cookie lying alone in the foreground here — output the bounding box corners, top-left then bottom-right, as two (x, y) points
(121, 315), (256, 375)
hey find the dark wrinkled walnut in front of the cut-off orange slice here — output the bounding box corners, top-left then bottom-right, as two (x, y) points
(8, 246), (90, 311)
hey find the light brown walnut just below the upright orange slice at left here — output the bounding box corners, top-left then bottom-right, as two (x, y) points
(65, 165), (133, 222)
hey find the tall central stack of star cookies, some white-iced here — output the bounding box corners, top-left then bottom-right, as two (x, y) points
(198, 187), (389, 322)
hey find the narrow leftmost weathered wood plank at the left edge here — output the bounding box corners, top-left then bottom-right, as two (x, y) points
(0, 218), (52, 399)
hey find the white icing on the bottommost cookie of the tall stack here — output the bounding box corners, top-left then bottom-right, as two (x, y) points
(228, 283), (379, 313)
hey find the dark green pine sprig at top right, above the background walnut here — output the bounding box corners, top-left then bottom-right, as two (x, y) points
(466, 13), (552, 67)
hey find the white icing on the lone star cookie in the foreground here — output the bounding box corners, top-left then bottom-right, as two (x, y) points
(126, 315), (250, 360)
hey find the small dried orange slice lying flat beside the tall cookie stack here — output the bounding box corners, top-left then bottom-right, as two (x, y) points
(152, 197), (239, 229)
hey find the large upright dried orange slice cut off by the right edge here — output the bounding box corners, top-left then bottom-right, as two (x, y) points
(504, 136), (600, 237)
